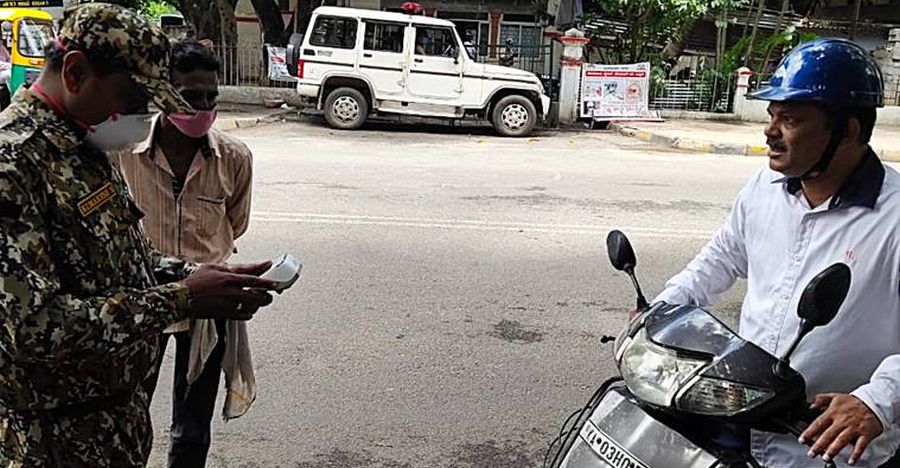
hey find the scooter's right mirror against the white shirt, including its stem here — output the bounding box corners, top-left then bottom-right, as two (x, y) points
(775, 263), (851, 377)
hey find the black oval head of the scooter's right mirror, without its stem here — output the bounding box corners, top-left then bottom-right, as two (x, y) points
(797, 263), (850, 327)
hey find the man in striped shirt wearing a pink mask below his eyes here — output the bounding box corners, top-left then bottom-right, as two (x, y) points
(112, 40), (256, 468)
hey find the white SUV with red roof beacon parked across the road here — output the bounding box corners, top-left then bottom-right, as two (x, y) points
(287, 7), (550, 136)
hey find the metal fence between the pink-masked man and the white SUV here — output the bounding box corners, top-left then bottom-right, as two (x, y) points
(215, 44), (296, 88)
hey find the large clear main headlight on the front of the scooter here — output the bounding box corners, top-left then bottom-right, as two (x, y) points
(618, 329), (707, 407)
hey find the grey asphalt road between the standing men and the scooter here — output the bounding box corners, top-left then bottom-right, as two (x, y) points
(151, 119), (765, 468)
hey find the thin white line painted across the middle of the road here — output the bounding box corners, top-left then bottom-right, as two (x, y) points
(252, 211), (712, 240)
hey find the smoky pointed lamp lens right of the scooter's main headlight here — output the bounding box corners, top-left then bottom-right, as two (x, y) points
(678, 377), (774, 416)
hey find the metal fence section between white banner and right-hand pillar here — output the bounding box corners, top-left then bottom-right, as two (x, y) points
(650, 77), (735, 113)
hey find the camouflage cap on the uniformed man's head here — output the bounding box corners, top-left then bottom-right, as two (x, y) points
(59, 3), (193, 114)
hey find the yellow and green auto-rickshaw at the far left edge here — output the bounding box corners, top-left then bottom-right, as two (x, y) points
(0, 8), (54, 108)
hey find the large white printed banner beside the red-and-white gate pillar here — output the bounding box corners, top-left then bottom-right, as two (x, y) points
(580, 62), (652, 120)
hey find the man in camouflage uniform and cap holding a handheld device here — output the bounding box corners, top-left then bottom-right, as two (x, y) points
(0, 3), (274, 468)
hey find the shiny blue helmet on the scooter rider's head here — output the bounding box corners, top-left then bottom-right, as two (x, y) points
(748, 38), (884, 108)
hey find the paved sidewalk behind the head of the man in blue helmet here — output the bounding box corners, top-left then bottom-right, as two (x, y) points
(610, 120), (900, 161)
